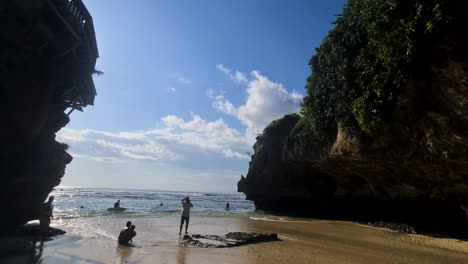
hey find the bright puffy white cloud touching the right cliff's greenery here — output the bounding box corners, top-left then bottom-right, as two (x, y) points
(207, 64), (303, 133)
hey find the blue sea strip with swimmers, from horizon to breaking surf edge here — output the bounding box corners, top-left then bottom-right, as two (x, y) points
(51, 187), (259, 219)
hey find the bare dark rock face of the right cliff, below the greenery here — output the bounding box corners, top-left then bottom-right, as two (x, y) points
(238, 0), (468, 235)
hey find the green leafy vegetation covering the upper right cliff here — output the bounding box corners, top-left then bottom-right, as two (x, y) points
(298, 0), (455, 142)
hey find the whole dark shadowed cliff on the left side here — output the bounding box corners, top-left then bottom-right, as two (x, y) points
(0, 0), (98, 226)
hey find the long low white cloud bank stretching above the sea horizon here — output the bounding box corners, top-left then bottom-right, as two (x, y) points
(57, 114), (252, 163)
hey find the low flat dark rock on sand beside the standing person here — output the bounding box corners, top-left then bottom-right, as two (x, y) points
(181, 232), (279, 248)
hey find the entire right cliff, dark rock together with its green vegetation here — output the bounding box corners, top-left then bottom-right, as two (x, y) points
(238, 0), (468, 235)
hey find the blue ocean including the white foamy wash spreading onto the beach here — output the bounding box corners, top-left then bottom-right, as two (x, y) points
(46, 186), (266, 247)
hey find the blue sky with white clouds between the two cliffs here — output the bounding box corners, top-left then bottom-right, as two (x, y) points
(57, 0), (346, 192)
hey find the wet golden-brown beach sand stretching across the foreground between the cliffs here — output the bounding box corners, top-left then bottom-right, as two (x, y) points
(0, 217), (468, 264)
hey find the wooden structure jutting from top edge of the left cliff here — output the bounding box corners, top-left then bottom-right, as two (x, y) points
(46, 0), (99, 114)
